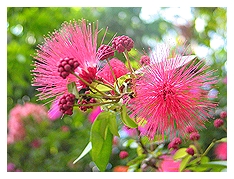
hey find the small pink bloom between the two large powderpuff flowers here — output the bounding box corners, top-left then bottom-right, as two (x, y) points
(97, 58), (129, 84)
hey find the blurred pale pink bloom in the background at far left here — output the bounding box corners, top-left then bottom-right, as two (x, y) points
(7, 103), (47, 144)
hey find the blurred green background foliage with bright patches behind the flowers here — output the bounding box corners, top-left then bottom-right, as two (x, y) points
(7, 7), (227, 171)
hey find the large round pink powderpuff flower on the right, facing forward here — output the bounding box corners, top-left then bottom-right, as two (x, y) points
(126, 44), (217, 139)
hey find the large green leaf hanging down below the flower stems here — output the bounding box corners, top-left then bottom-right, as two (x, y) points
(90, 112), (113, 171)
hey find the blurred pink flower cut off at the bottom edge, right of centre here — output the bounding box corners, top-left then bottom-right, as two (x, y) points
(158, 155), (180, 172)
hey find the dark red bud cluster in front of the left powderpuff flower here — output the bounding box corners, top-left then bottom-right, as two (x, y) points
(58, 58), (80, 79)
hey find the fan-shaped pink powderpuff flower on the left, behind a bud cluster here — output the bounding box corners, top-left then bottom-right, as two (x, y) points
(32, 20), (99, 103)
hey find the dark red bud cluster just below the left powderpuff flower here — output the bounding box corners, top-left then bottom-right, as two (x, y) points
(59, 93), (75, 115)
